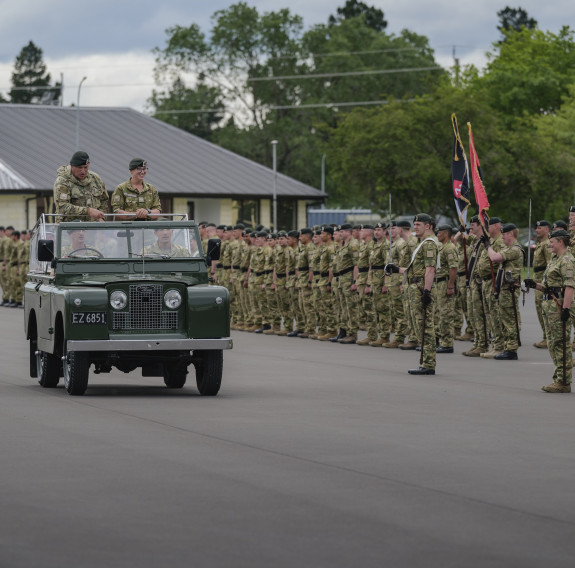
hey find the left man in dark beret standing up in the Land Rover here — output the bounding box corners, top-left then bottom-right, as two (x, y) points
(54, 150), (110, 221)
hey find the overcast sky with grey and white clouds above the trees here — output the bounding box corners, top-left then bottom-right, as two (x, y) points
(0, 0), (575, 110)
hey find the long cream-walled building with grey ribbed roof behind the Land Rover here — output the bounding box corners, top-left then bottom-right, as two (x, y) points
(0, 104), (327, 228)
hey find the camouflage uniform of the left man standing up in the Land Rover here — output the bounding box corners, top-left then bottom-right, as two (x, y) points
(54, 166), (110, 221)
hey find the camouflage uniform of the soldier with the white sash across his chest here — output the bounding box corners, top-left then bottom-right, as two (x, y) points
(405, 237), (439, 370)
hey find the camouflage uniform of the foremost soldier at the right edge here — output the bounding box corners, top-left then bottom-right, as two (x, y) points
(542, 250), (575, 385)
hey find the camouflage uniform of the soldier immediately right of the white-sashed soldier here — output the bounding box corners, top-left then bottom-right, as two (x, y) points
(435, 241), (458, 347)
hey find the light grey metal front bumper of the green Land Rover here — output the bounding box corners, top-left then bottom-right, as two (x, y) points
(66, 337), (233, 351)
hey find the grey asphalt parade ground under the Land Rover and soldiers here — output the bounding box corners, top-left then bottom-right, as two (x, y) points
(0, 300), (575, 568)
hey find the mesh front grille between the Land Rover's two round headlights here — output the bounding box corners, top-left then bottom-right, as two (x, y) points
(112, 284), (178, 330)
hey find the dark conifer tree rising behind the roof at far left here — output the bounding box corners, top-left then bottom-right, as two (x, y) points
(9, 41), (60, 104)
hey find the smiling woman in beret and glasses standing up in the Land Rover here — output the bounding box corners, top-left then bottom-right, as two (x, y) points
(112, 158), (162, 221)
